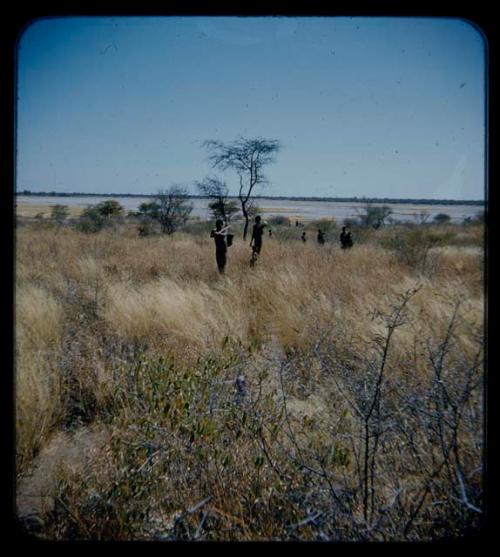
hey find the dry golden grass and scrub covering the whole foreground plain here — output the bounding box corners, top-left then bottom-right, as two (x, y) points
(15, 214), (484, 541)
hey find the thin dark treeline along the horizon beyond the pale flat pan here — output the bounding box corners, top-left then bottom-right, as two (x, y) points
(17, 190), (484, 206)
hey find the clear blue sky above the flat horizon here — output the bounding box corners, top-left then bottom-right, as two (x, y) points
(17, 16), (485, 199)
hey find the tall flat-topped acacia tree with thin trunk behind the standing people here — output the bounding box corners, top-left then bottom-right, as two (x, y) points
(203, 137), (281, 240)
